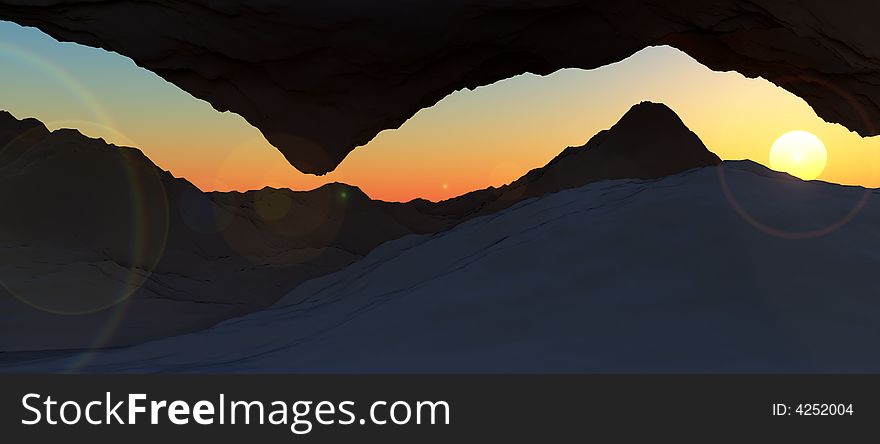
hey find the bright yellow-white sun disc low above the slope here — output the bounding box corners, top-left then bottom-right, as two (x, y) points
(770, 131), (828, 180)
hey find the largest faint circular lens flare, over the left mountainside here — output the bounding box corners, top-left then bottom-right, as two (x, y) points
(0, 122), (169, 370)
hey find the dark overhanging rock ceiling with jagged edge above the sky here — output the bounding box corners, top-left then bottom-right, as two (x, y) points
(0, 0), (880, 173)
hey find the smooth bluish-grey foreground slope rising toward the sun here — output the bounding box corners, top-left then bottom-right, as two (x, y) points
(0, 162), (880, 372)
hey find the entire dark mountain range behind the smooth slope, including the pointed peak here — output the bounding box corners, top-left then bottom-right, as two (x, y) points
(0, 102), (720, 351)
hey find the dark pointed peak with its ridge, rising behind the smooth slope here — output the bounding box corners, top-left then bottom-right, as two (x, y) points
(386, 102), (721, 233)
